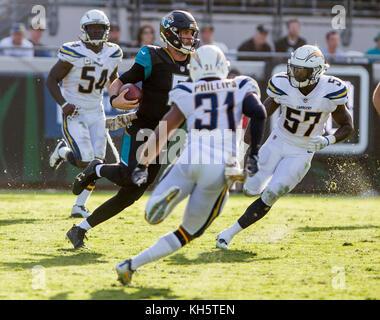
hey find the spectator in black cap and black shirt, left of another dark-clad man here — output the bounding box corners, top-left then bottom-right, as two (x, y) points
(238, 24), (272, 61)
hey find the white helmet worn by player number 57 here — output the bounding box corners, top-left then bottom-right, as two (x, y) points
(287, 45), (328, 88)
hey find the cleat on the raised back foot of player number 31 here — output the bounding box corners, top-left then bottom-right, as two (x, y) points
(145, 186), (181, 224)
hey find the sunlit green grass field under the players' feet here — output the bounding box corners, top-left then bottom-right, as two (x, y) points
(0, 191), (380, 300)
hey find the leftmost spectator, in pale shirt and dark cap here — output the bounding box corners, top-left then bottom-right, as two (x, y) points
(0, 23), (34, 57)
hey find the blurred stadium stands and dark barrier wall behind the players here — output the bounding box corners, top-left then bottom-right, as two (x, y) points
(0, 0), (380, 195)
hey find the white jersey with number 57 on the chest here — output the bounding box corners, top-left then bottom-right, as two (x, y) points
(267, 72), (348, 147)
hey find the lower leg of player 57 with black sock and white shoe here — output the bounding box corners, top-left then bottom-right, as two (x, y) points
(216, 198), (271, 249)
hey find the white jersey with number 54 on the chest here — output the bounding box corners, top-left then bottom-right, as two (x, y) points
(58, 41), (123, 110)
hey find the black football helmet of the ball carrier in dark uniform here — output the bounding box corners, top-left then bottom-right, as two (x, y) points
(160, 10), (199, 54)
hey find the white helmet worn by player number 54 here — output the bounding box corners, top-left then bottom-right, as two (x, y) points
(80, 9), (110, 46)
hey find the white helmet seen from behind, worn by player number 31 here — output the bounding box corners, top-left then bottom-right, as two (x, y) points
(188, 45), (230, 82)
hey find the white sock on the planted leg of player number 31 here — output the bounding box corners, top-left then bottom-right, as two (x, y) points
(131, 232), (182, 270)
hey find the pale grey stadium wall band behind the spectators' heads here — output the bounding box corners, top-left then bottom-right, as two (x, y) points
(42, 7), (380, 52)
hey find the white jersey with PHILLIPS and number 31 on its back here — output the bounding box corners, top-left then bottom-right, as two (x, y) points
(168, 76), (260, 161)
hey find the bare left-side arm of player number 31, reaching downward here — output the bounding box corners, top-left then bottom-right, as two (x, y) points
(138, 104), (186, 166)
